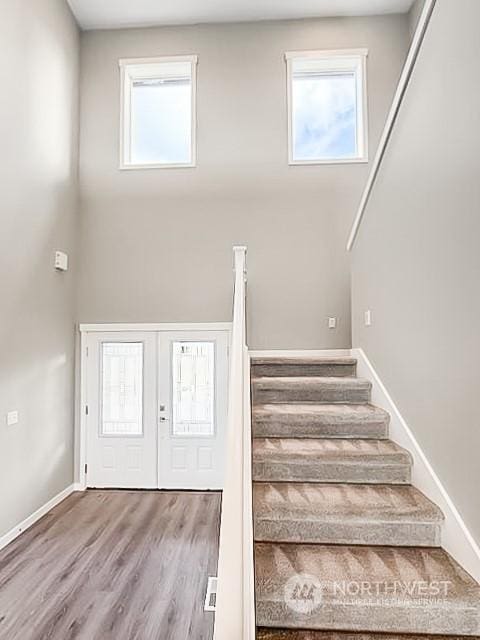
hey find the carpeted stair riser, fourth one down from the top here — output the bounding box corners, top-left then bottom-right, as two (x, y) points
(252, 459), (411, 484)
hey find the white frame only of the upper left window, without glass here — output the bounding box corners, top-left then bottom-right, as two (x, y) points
(119, 55), (198, 170)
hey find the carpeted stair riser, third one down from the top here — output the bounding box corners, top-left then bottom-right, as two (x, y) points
(252, 418), (388, 440)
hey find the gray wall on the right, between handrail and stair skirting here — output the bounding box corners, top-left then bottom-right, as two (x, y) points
(353, 0), (480, 541)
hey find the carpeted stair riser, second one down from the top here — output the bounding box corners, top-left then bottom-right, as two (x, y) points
(252, 381), (370, 405)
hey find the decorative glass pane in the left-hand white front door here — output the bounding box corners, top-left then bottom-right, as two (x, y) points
(100, 342), (143, 436)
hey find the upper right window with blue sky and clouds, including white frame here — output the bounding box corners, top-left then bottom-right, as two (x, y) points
(286, 50), (368, 164)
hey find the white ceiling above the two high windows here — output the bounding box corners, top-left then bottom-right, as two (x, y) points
(68, 0), (414, 29)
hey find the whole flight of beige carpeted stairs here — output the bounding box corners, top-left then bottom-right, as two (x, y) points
(252, 358), (480, 640)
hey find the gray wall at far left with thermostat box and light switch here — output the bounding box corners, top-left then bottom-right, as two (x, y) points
(0, 0), (79, 535)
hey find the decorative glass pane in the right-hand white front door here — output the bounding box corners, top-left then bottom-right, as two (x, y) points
(172, 342), (215, 436)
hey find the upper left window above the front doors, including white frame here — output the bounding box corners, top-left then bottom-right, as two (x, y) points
(120, 56), (197, 169)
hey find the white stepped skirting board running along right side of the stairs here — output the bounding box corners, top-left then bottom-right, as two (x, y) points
(351, 349), (480, 582)
